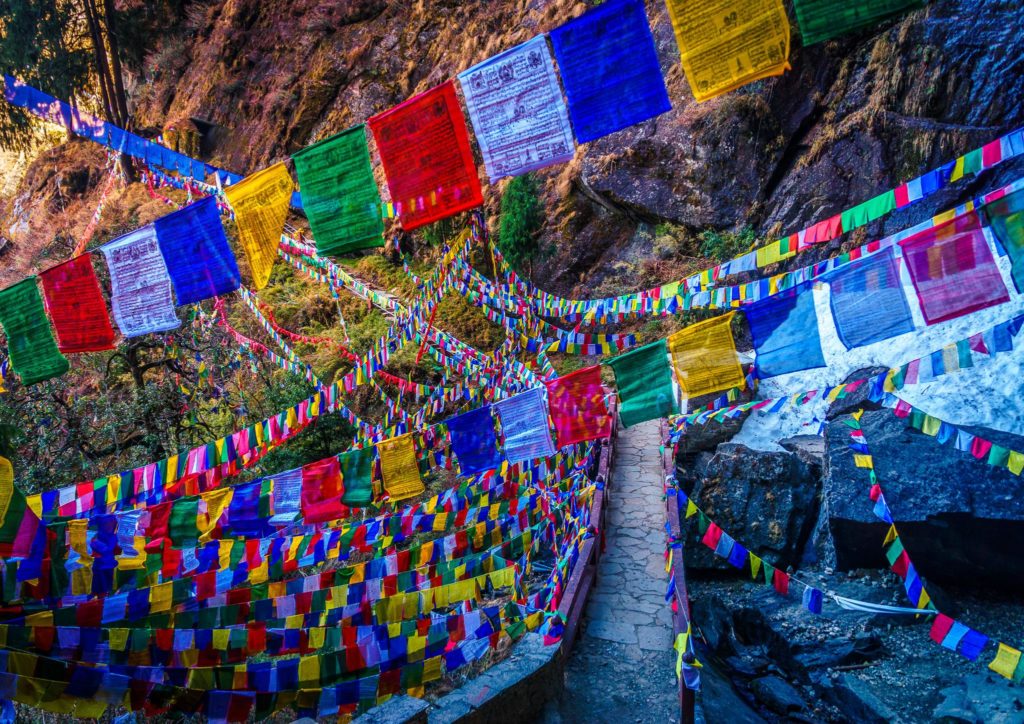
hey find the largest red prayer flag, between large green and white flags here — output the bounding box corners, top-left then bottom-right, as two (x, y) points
(368, 81), (483, 231)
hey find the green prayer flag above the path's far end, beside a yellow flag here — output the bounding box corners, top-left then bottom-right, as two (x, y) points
(608, 339), (679, 427)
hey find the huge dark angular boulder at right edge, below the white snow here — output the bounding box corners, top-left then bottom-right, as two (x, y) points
(822, 410), (1024, 591)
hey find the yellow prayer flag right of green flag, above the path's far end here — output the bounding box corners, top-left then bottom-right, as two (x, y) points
(668, 312), (743, 398)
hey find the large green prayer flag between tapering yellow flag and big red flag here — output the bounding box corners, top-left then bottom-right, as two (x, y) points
(292, 125), (384, 256)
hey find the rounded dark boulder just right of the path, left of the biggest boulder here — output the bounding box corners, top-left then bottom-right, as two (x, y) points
(681, 442), (819, 569)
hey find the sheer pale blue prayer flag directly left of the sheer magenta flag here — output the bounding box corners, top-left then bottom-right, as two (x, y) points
(823, 248), (913, 349)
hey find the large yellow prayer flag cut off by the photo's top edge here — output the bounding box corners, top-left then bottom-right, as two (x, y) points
(667, 0), (790, 102)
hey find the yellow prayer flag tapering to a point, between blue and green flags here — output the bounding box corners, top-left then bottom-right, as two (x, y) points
(224, 163), (295, 290)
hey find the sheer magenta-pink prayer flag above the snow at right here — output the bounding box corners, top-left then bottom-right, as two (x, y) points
(899, 212), (1010, 325)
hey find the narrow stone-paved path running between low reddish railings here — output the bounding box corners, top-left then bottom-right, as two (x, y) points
(543, 420), (679, 724)
